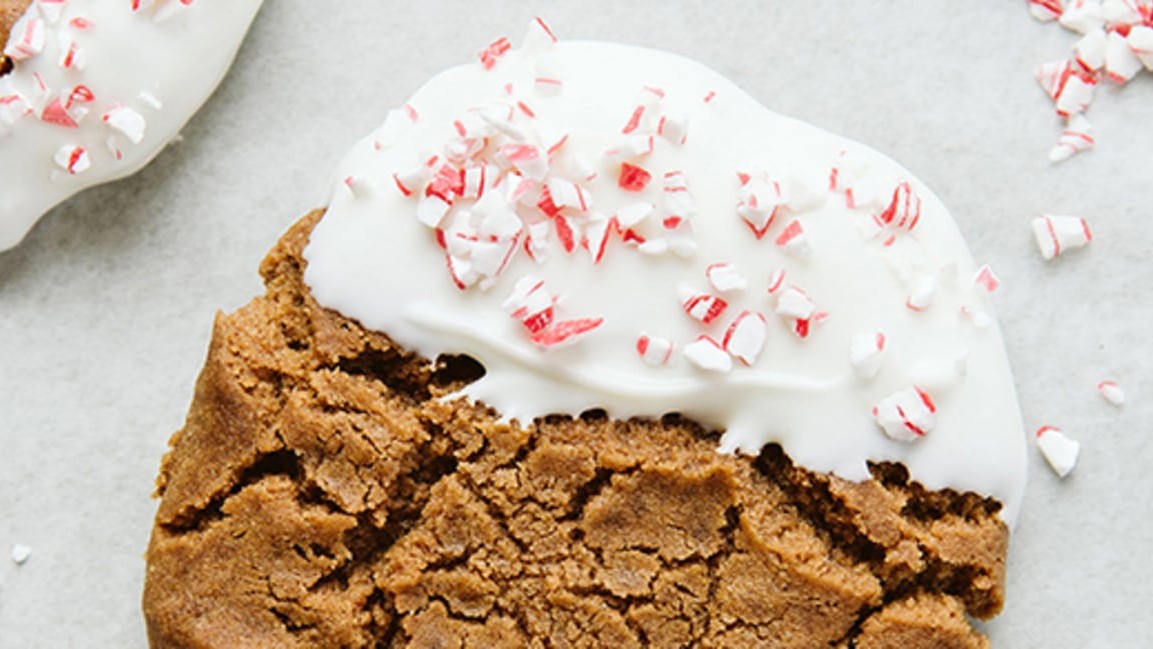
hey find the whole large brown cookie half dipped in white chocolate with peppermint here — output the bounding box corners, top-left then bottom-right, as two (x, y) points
(145, 17), (1025, 647)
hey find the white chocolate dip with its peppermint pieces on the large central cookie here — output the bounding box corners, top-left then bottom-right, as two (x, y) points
(306, 21), (1026, 525)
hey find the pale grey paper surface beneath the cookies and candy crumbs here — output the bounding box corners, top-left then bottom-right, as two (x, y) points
(0, 0), (1153, 649)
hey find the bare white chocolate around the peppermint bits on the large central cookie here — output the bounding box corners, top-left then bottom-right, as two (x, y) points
(304, 41), (1026, 526)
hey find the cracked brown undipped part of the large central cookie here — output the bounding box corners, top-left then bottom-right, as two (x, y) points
(144, 212), (1008, 649)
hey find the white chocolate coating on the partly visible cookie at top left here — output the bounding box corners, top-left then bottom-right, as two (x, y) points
(0, 0), (262, 250)
